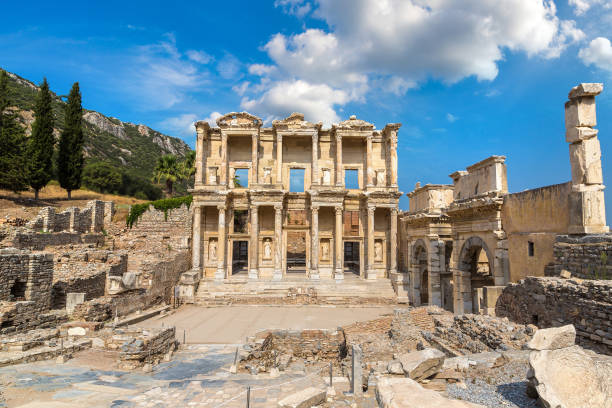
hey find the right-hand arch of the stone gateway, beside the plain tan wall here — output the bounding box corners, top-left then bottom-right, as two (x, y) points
(455, 236), (503, 313)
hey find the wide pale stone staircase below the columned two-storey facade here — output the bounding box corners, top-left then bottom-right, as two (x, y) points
(195, 275), (397, 306)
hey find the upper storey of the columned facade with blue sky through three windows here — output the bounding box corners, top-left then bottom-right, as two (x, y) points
(194, 112), (401, 193)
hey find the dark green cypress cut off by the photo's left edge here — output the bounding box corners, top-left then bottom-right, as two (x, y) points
(0, 70), (28, 192)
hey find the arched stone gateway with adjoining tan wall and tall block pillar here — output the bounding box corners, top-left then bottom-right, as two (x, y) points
(402, 84), (609, 313)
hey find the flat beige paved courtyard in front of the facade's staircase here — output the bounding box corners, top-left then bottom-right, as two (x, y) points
(138, 305), (398, 344)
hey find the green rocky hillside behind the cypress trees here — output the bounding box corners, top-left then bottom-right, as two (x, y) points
(2, 72), (190, 180)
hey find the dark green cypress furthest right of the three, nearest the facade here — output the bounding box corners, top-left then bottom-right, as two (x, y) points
(57, 82), (84, 200)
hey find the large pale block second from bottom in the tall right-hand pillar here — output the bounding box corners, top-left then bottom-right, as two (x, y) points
(570, 138), (603, 185)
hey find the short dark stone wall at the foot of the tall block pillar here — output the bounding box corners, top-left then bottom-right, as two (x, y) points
(546, 234), (612, 279)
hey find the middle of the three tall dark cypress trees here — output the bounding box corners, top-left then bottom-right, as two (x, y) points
(26, 78), (55, 200)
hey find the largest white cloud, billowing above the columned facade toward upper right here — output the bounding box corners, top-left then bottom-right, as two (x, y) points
(245, 0), (584, 124)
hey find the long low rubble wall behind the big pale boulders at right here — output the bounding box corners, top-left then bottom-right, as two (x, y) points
(495, 277), (612, 355)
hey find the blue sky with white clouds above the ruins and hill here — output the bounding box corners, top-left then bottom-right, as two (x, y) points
(0, 0), (612, 218)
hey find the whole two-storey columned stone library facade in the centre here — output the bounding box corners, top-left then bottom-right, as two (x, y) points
(192, 112), (401, 281)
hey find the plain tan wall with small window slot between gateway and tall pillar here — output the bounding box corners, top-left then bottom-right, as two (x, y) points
(502, 182), (571, 282)
